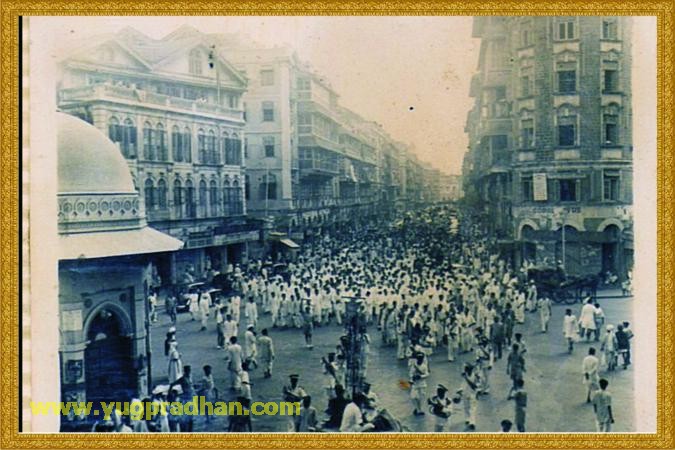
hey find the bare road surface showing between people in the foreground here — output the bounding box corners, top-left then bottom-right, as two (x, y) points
(152, 290), (634, 432)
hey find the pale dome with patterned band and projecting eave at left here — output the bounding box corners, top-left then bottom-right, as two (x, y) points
(56, 113), (183, 259)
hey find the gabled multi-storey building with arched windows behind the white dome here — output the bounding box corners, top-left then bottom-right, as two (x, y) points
(58, 27), (260, 282)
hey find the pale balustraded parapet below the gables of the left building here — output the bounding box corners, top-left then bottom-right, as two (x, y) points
(59, 84), (244, 121)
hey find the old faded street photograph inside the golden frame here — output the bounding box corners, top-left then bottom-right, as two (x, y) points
(22, 15), (657, 434)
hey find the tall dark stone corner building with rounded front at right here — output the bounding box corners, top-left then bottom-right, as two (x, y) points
(464, 17), (633, 275)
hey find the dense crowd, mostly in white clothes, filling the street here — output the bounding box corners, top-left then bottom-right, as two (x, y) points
(93, 206), (632, 432)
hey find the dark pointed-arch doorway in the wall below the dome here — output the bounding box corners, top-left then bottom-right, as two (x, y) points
(84, 307), (138, 404)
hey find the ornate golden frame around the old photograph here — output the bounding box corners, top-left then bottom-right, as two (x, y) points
(0, 0), (675, 449)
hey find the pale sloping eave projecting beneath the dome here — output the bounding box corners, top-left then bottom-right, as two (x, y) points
(59, 227), (183, 259)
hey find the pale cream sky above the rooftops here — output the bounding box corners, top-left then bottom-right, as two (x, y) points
(40, 16), (480, 174)
